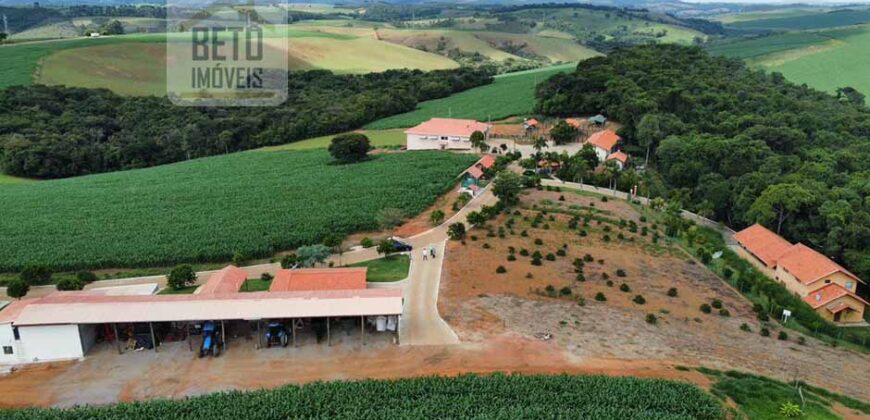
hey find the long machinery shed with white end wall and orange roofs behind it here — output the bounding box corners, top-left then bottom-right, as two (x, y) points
(0, 266), (403, 363)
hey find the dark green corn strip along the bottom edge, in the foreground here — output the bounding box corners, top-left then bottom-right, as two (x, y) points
(0, 375), (724, 420)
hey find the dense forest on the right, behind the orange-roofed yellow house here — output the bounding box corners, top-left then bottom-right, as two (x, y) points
(537, 45), (870, 279)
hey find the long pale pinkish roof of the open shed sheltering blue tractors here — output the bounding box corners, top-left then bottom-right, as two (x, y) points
(11, 289), (402, 326)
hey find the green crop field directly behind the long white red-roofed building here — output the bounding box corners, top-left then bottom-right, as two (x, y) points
(366, 64), (576, 130)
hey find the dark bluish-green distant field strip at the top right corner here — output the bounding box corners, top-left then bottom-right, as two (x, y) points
(730, 9), (870, 31)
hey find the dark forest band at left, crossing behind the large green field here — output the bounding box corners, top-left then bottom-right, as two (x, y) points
(0, 69), (492, 178)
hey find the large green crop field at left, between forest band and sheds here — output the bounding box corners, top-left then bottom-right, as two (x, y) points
(0, 150), (477, 272)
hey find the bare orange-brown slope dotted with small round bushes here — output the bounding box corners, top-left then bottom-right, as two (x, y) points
(438, 190), (870, 400)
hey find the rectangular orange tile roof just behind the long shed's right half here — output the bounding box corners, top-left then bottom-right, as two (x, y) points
(269, 267), (368, 292)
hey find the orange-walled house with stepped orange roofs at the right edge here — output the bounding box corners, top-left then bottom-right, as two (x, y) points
(734, 224), (867, 323)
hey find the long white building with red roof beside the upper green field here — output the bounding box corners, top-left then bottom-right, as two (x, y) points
(405, 118), (492, 150)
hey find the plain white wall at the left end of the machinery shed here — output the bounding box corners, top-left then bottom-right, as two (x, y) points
(18, 324), (84, 362)
